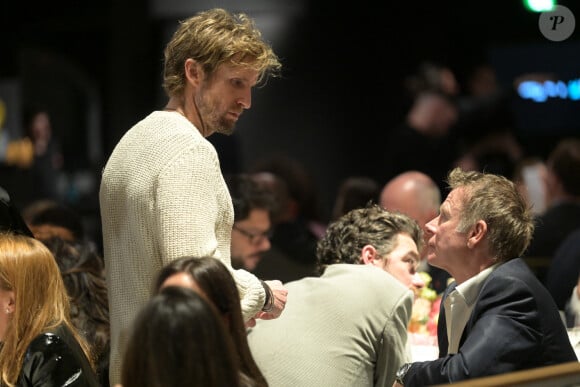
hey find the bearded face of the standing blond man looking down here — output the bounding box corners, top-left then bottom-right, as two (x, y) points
(194, 58), (259, 136)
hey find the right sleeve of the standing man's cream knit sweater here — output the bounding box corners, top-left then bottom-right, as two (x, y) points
(154, 137), (266, 321)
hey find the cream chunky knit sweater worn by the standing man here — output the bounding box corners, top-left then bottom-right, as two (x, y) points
(99, 111), (265, 385)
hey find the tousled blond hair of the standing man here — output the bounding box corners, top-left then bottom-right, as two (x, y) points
(163, 8), (281, 97)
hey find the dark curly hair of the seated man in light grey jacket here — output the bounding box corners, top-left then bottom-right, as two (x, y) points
(316, 204), (423, 274)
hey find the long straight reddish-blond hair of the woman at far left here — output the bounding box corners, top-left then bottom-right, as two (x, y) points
(0, 233), (92, 387)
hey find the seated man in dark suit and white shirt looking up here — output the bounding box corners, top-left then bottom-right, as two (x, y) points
(394, 169), (577, 386)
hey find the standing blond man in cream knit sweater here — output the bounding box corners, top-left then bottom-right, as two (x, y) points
(99, 9), (287, 385)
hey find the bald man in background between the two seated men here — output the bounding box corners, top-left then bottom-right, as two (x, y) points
(379, 171), (450, 293)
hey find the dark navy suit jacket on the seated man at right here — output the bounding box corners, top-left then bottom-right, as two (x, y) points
(404, 258), (577, 386)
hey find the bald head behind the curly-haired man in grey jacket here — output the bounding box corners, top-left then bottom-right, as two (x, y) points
(380, 171), (441, 228)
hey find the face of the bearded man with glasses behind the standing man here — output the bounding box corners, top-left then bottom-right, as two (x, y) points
(231, 208), (271, 271)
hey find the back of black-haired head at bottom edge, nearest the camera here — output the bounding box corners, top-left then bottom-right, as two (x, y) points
(121, 286), (241, 387)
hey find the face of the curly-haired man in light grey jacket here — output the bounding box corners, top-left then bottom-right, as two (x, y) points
(373, 234), (425, 289)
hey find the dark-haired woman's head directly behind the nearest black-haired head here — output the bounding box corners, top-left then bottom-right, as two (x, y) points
(153, 257), (268, 387)
